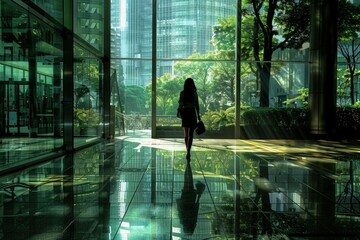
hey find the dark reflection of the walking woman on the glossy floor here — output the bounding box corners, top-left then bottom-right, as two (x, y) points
(176, 162), (205, 235)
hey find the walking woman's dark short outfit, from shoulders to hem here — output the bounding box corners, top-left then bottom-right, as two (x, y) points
(179, 91), (199, 129)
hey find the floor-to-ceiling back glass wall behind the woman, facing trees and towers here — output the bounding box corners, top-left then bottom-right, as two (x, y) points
(112, 0), (360, 138)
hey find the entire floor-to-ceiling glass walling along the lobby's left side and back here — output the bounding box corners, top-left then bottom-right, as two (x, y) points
(0, 0), (360, 161)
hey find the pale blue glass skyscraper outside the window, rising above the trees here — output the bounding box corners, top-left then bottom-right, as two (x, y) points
(113, 0), (236, 86)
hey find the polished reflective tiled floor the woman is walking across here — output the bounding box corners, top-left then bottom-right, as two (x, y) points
(0, 136), (360, 240)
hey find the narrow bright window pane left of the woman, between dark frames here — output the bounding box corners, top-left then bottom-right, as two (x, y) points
(111, 0), (153, 135)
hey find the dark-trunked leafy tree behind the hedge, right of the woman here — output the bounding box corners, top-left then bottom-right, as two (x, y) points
(244, 0), (310, 107)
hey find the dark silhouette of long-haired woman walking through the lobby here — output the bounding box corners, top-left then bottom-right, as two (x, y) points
(179, 78), (200, 160)
